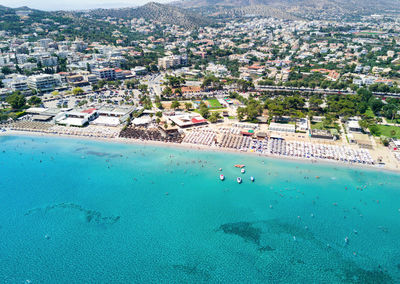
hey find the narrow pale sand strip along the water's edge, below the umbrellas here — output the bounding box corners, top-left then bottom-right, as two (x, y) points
(0, 130), (400, 174)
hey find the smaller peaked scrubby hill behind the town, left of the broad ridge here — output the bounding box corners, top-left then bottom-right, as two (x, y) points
(90, 2), (212, 28)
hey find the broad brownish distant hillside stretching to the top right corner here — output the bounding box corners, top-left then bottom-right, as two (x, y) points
(174, 0), (400, 19)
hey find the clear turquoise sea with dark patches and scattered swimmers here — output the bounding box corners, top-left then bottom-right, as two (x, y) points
(0, 136), (400, 283)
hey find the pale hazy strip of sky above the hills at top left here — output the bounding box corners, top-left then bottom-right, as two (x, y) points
(0, 0), (170, 11)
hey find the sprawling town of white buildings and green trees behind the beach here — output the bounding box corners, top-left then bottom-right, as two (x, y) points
(0, 11), (400, 169)
